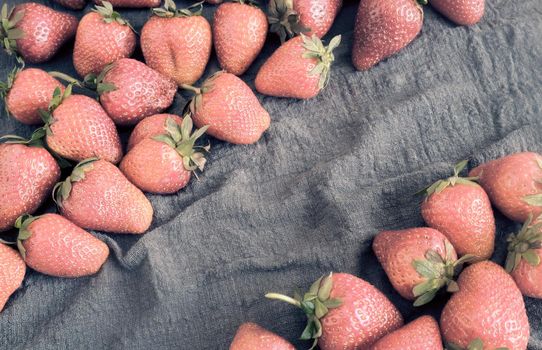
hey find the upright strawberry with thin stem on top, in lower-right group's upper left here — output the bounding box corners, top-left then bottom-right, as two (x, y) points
(422, 161), (495, 259)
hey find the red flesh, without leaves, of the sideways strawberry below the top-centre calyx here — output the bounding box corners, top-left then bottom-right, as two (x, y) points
(255, 36), (320, 99)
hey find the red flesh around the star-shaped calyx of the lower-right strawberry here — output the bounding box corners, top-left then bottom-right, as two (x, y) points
(373, 227), (457, 300)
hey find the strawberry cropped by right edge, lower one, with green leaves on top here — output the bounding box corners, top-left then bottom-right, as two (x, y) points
(506, 218), (542, 298)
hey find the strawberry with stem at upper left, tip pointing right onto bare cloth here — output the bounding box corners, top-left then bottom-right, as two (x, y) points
(182, 71), (271, 144)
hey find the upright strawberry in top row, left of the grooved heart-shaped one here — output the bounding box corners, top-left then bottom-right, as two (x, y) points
(73, 1), (136, 77)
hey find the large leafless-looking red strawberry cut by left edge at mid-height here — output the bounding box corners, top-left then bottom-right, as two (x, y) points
(0, 144), (60, 231)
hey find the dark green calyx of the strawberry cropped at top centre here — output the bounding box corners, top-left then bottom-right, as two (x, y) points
(267, 0), (310, 43)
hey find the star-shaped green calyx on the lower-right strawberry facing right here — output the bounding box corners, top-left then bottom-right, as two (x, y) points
(412, 240), (476, 306)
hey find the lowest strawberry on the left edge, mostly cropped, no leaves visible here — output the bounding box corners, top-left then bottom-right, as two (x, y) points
(0, 243), (26, 311)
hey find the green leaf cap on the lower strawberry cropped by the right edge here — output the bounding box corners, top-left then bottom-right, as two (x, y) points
(505, 215), (542, 273)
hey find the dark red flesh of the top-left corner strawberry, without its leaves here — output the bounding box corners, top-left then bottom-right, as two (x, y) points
(12, 2), (77, 63)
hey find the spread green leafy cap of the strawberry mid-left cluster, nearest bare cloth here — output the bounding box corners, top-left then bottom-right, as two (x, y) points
(152, 115), (211, 173)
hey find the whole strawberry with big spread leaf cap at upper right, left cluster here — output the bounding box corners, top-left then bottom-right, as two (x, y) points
(120, 116), (209, 194)
